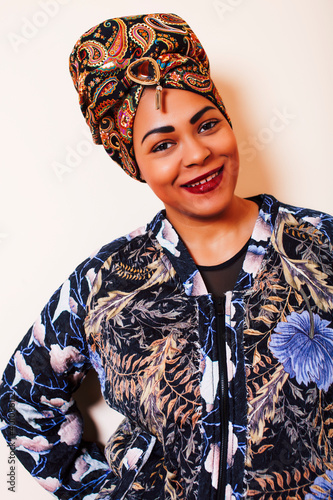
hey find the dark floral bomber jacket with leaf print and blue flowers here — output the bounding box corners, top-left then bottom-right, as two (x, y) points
(0, 195), (333, 500)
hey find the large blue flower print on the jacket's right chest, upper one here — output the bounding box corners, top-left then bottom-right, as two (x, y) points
(269, 311), (333, 391)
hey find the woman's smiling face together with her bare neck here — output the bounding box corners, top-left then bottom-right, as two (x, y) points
(133, 89), (258, 265)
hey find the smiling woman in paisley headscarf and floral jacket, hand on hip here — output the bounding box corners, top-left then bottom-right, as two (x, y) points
(1, 14), (333, 500)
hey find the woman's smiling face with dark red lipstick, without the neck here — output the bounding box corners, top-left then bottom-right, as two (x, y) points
(133, 88), (239, 222)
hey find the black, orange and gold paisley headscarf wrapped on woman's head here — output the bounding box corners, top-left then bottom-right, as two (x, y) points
(70, 14), (230, 181)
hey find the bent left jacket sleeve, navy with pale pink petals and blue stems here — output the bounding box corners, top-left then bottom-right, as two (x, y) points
(0, 245), (122, 499)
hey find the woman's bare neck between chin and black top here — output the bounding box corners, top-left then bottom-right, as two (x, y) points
(167, 196), (258, 266)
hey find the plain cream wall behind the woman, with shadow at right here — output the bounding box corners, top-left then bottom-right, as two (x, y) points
(0, 0), (333, 500)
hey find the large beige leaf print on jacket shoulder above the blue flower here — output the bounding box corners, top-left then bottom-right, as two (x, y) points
(271, 213), (333, 312)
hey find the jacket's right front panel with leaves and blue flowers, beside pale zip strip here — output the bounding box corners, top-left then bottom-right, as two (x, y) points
(244, 201), (333, 500)
